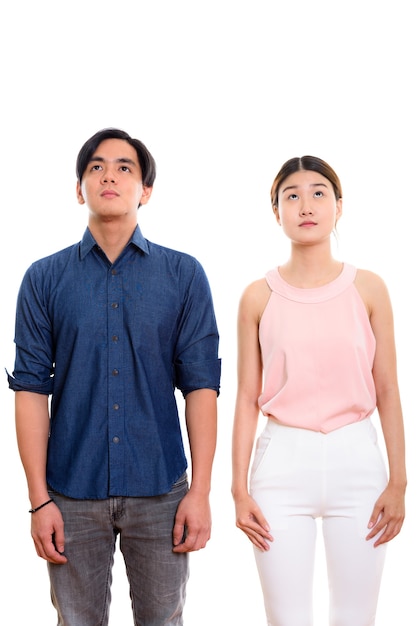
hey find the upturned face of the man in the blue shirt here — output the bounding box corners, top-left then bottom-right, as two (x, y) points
(77, 139), (152, 221)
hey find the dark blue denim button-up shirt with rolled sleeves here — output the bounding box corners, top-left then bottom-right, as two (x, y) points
(8, 227), (220, 499)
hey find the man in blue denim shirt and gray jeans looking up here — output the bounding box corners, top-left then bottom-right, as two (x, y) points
(9, 128), (220, 626)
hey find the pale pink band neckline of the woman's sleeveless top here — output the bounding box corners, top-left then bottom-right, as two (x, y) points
(266, 263), (357, 302)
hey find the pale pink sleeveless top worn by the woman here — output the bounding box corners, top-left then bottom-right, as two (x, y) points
(259, 264), (376, 433)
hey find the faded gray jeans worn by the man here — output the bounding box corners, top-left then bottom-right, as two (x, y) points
(48, 474), (189, 626)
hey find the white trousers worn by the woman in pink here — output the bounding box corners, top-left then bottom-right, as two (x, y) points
(250, 419), (387, 626)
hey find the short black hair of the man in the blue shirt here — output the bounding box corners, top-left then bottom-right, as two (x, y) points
(76, 128), (157, 187)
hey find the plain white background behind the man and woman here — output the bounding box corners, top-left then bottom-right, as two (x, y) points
(0, 0), (418, 626)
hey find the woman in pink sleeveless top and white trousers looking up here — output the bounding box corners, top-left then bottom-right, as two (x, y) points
(232, 156), (406, 626)
